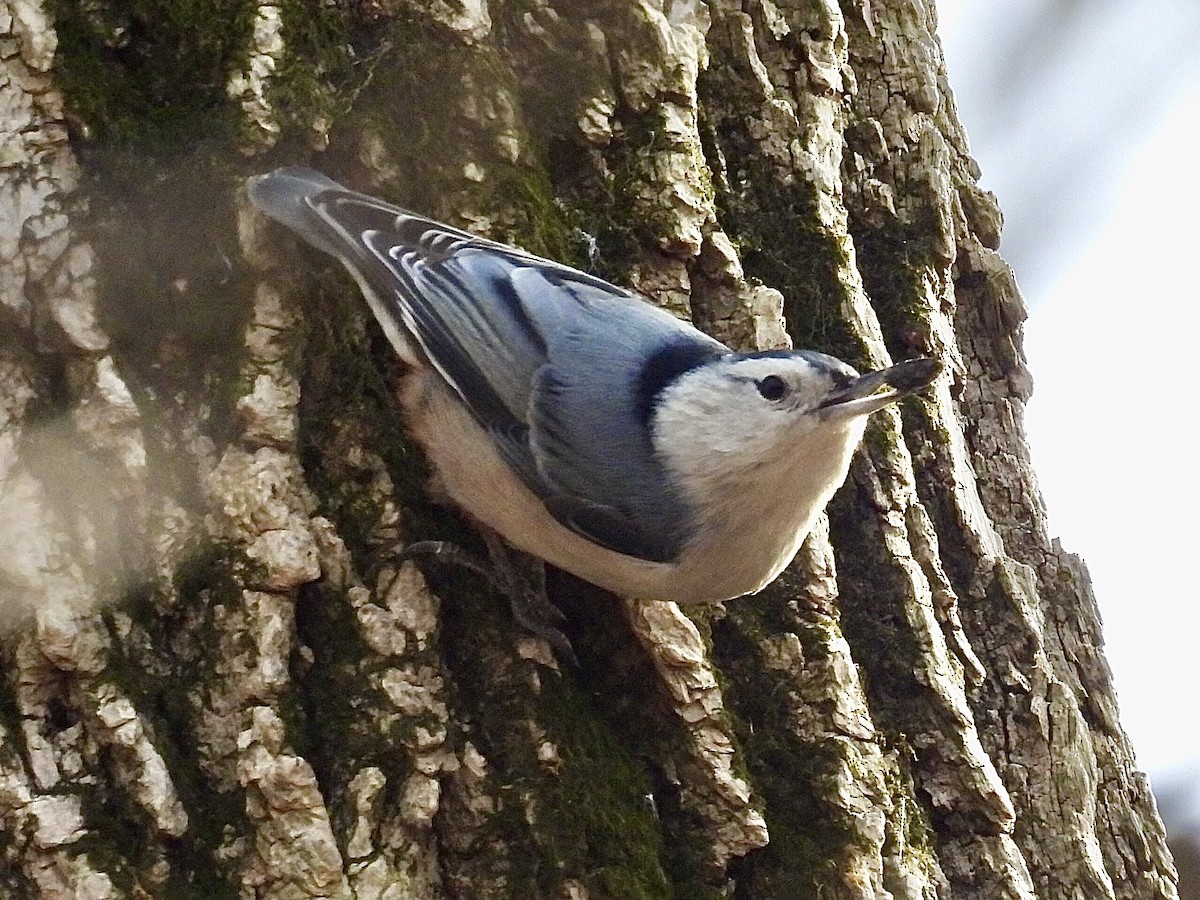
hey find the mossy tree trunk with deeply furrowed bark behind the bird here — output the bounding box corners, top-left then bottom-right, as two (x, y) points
(0, 0), (1176, 900)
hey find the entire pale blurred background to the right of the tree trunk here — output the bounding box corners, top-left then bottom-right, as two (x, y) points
(936, 0), (1200, 898)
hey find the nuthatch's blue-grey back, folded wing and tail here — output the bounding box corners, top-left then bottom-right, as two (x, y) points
(250, 169), (728, 562)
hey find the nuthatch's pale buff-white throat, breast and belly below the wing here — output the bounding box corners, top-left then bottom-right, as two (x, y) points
(401, 368), (863, 604)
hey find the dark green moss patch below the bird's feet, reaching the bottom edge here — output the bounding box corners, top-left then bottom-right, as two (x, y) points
(431, 580), (672, 900)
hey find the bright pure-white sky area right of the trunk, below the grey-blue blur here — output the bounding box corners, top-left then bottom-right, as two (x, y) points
(1018, 90), (1200, 774)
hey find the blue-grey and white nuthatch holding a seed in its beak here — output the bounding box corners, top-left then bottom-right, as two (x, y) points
(248, 168), (941, 604)
